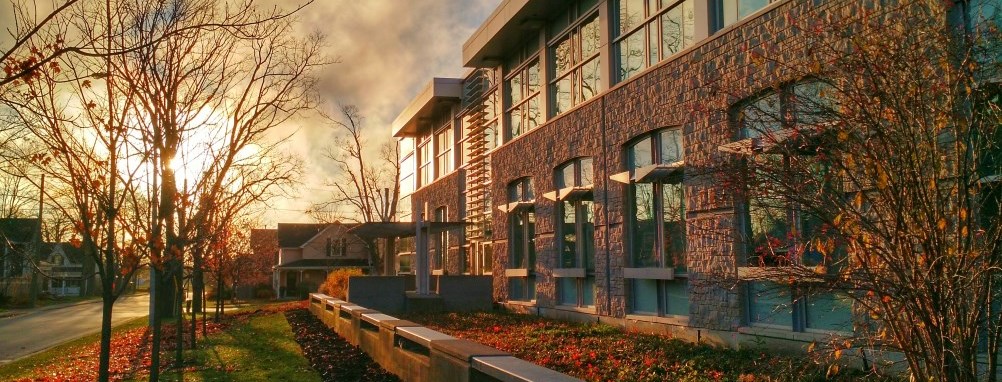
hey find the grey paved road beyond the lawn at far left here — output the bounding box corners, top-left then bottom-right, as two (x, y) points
(0, 295), (149, 364)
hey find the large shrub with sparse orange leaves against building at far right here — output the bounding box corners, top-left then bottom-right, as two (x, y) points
(709, 0), (1002, 381)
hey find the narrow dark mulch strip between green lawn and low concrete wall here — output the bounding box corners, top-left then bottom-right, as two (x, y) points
(286, 309), (400, 381)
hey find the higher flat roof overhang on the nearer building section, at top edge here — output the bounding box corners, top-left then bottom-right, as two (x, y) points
(463, 0), (569, 67)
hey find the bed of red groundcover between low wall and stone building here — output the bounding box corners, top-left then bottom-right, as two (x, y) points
(407, 312), (885, 382)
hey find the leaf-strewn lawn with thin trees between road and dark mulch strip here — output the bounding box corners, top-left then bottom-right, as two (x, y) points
(0, 298), (320, 381)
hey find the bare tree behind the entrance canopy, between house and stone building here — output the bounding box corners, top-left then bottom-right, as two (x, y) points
(311, 105), (400, 274)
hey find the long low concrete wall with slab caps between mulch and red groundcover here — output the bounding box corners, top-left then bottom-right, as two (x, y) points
(310, 293), (580, 382)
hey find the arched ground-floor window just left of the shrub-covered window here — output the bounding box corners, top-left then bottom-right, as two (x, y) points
(625, 128), (689, 316)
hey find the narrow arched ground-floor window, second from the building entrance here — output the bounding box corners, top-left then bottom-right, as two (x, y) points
(554, 157), (595, 307)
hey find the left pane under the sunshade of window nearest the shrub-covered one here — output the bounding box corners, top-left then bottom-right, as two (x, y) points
(631, 183), (660, 267)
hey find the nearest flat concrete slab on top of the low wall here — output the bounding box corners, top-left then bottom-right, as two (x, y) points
(470, 356), (581, 382)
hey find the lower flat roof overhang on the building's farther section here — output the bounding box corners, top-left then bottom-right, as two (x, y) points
(393, 77), (463, 137)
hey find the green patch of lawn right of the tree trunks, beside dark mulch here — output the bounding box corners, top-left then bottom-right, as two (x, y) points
(138, 313), (320, 381)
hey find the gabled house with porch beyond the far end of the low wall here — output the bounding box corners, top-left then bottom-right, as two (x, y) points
(273, 223), (372, 298)
